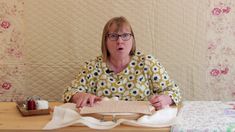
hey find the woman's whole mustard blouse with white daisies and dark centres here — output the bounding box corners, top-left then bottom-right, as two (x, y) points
(63, 52), (181, 104)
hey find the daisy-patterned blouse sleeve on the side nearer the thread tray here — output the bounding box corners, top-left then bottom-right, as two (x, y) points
(62, 62), (94, 102)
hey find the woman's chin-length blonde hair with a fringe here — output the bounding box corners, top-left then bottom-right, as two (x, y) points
(101, 16), (136, 62)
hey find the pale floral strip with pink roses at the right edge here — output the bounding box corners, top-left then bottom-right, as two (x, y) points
(207, 0), (235, 100)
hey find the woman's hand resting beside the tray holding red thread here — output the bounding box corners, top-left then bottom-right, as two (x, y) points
(72, 92), (102, 108)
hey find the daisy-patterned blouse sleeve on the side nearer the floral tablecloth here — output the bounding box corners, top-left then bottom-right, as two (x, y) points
(146, 55), (181, 105)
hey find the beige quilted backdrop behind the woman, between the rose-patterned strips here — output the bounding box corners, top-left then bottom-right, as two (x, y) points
(1, 0), (231, 100)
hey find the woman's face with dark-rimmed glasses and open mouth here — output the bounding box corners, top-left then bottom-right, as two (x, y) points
(106, 24), (133, 58)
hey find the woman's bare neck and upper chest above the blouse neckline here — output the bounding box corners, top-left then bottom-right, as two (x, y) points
(108, 56), (131, 73)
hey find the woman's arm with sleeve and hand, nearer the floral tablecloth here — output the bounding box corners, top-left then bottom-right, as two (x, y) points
(146, 56), (181, 109)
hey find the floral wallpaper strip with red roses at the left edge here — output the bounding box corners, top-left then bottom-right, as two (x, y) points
(0, 0), (24, 101)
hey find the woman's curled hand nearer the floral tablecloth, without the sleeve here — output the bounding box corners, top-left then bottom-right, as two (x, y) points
(149, 95), (173, 110)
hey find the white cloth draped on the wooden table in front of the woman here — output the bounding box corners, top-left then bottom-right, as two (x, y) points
(43, 103), (177, 130)
